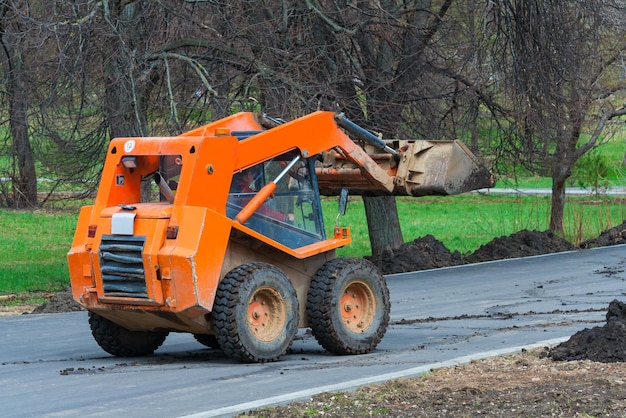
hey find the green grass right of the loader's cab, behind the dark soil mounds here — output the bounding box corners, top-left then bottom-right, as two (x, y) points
(324, 193), (626, 256)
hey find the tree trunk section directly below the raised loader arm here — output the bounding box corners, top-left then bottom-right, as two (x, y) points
(363, 196), (404, 255)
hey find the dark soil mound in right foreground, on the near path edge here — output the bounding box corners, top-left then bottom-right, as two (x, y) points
(548, 300), (626, 363)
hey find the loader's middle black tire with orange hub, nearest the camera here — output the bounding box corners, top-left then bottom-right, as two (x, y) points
(212, 262), (298, 363)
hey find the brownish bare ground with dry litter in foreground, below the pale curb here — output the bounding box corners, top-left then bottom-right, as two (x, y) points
(240, 351), (626, 418)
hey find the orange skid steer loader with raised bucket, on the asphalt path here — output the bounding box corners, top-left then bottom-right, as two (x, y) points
(68, 111), (493, 362)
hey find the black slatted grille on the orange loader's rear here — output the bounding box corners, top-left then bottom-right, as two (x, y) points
(100, 235), (148, 298)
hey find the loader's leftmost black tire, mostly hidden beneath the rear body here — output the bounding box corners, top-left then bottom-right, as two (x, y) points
(89, 312), (169, 357)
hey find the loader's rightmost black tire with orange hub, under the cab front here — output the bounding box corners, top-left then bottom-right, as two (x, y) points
(306, 258), (390, 354)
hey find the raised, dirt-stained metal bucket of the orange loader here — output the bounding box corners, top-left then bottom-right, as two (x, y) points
(394, 140), (495, 196)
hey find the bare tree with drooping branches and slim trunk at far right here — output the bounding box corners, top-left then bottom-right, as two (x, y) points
(492, 0), (626, 233)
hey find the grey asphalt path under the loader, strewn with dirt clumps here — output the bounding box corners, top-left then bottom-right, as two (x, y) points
(0, 245), (626, 418)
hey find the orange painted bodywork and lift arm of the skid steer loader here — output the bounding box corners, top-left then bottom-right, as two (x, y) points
(68, 112), (358, 333)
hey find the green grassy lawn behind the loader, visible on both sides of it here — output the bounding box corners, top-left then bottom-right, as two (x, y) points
(0, 193), (626, 295)
